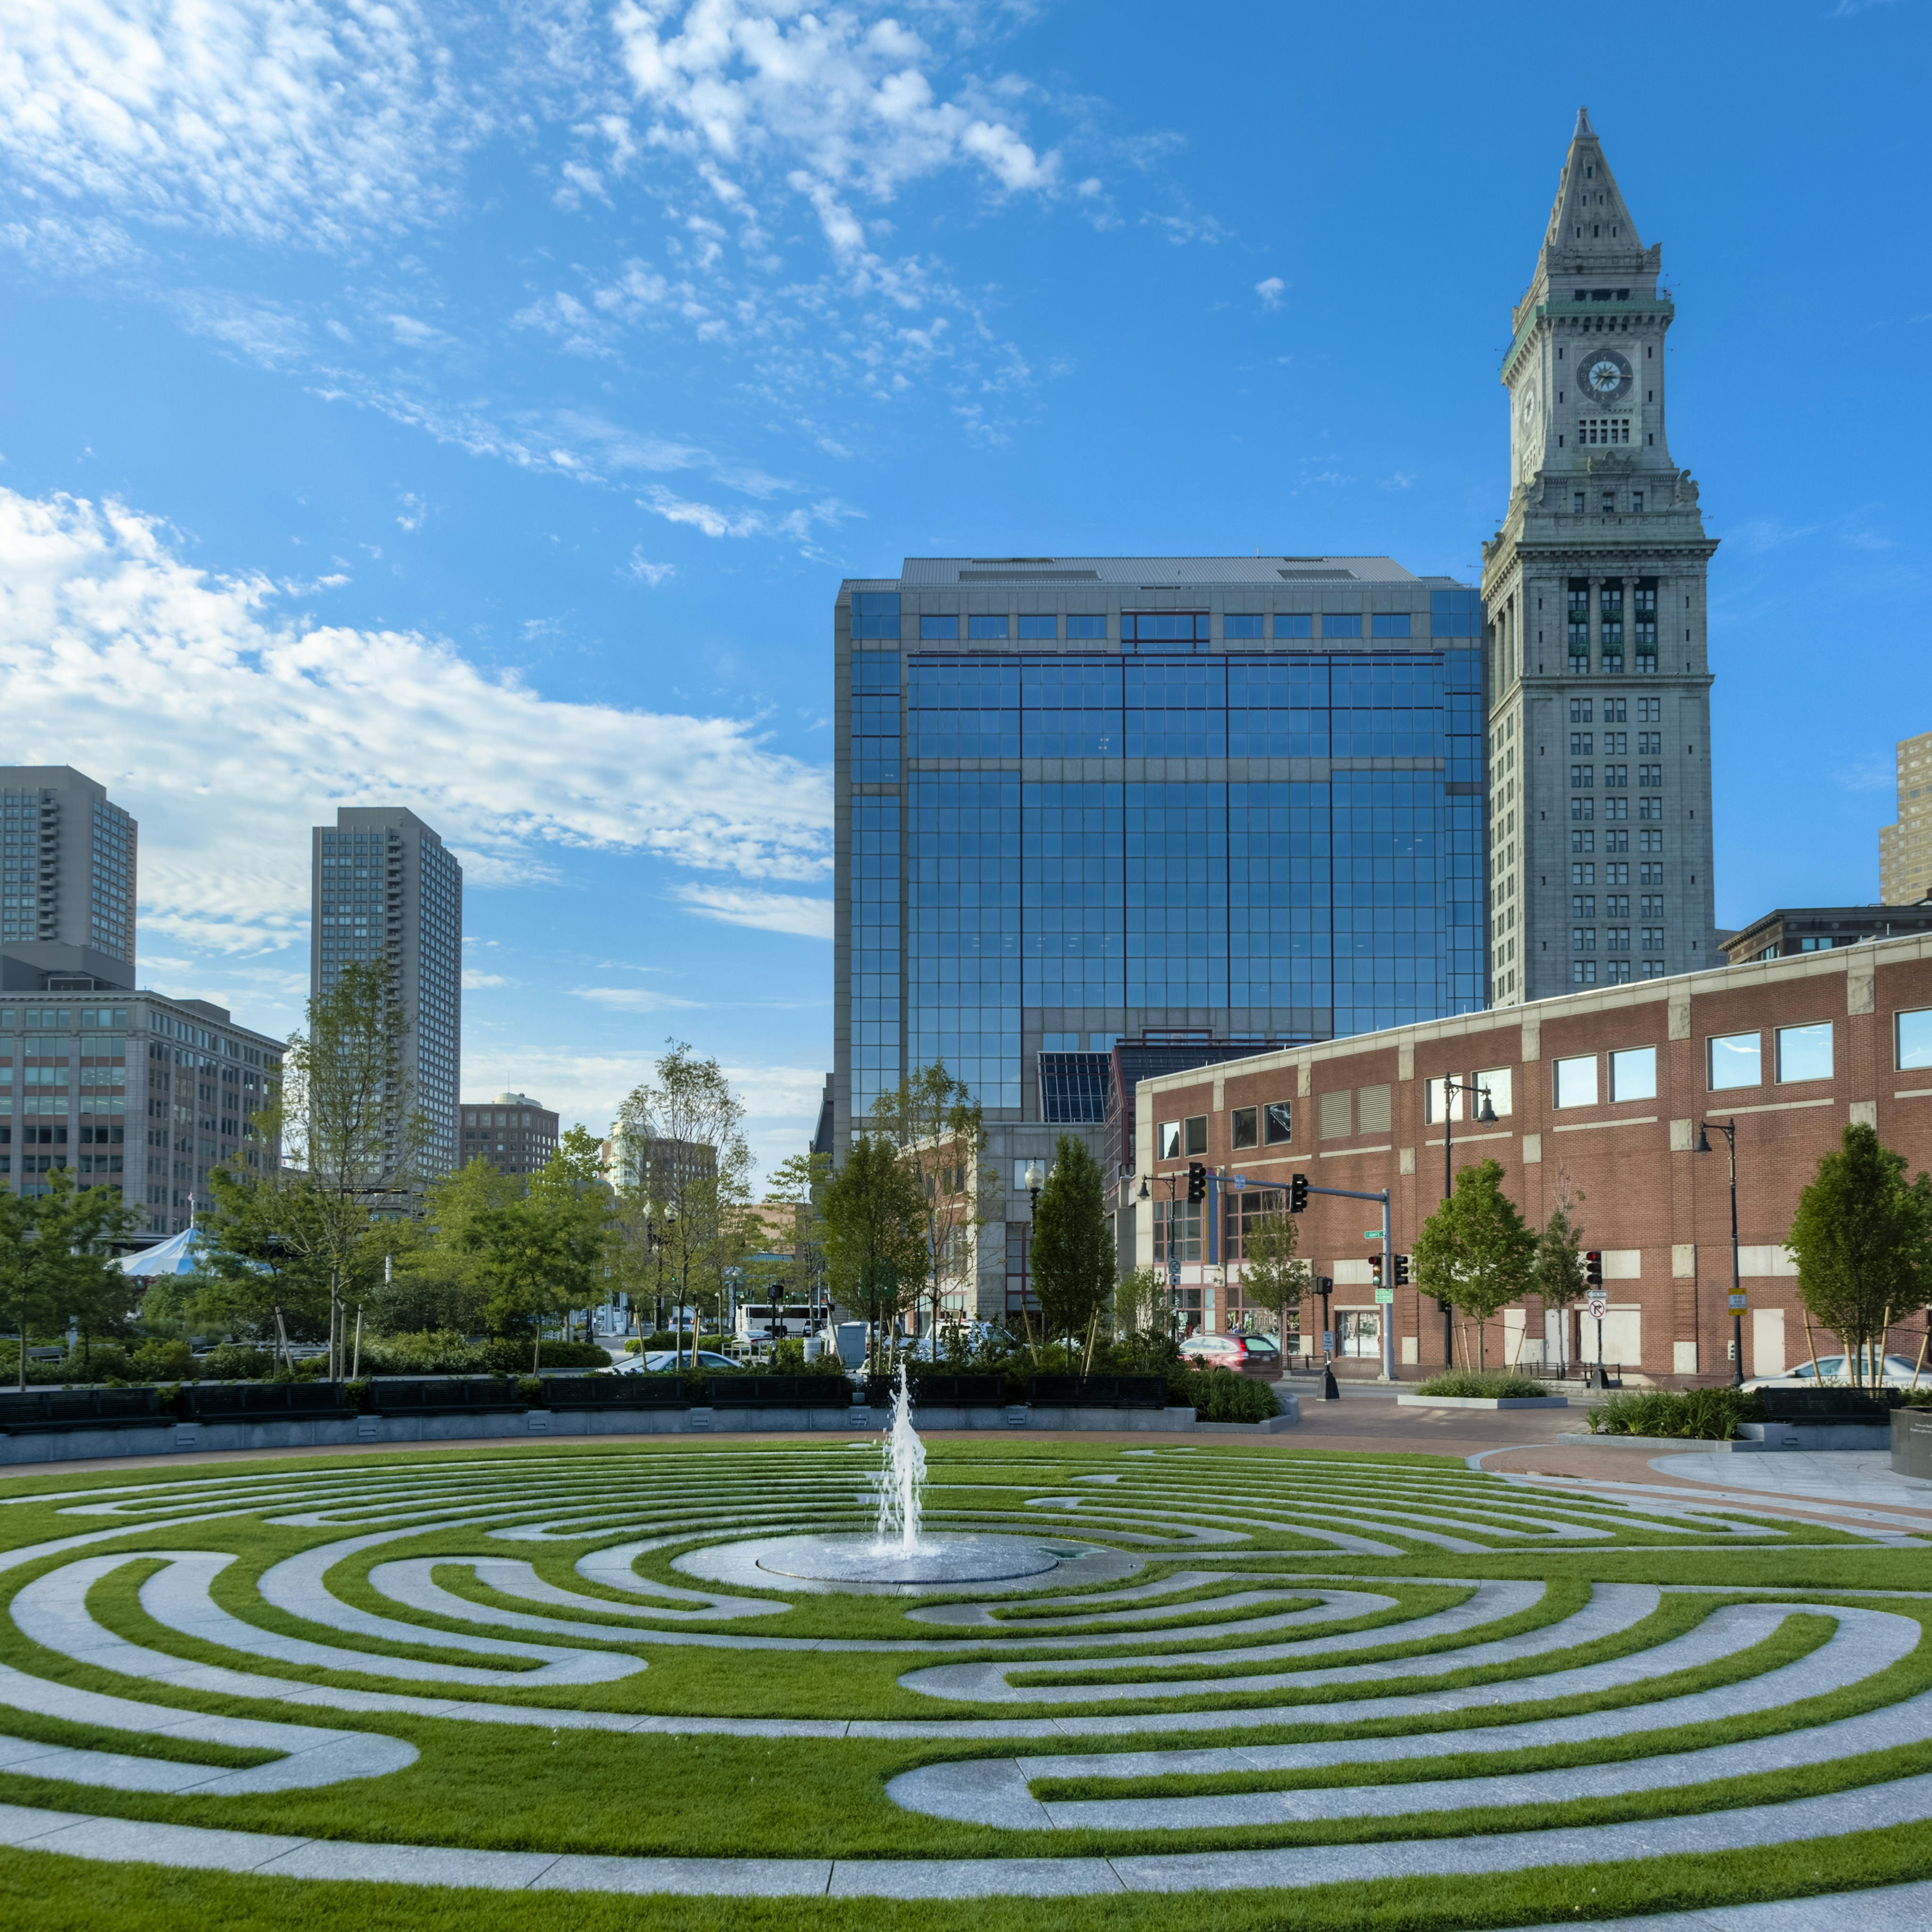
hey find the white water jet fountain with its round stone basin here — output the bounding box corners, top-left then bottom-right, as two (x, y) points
(757, 1362), (1059, 1584)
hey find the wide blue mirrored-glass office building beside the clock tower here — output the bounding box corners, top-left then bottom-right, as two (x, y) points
(835, 556), (1488, 1312)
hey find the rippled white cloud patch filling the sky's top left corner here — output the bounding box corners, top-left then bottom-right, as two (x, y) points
(0, 0), (473, 248)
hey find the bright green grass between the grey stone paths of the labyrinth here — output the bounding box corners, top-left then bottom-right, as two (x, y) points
(0, 1437), (1932, 1932)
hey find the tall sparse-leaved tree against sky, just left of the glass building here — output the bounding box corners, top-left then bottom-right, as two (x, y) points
(618, 1039), (752, 1360)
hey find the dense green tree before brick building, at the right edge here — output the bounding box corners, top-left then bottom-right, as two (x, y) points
(1785, 1126), (1932, 1382)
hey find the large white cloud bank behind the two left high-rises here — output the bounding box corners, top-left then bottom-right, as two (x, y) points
(0, 489), (831, 952)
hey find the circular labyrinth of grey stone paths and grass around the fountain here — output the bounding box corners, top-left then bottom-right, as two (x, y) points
(0, 1439), (1932, 1928)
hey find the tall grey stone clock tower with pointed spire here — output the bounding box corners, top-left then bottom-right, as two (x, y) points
(1482, 108), (1723, 1007)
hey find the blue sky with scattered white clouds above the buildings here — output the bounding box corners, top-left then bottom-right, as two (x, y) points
(0, 0), (1932, 1159)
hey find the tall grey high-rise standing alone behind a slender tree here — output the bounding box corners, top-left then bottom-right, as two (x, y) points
(309, 806), (464, 1175)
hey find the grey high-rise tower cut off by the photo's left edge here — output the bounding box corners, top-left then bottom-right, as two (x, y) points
(0, 765), (139, 985)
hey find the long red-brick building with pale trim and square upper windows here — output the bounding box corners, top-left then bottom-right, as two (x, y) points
(1115, 935), (1932, 1385)
